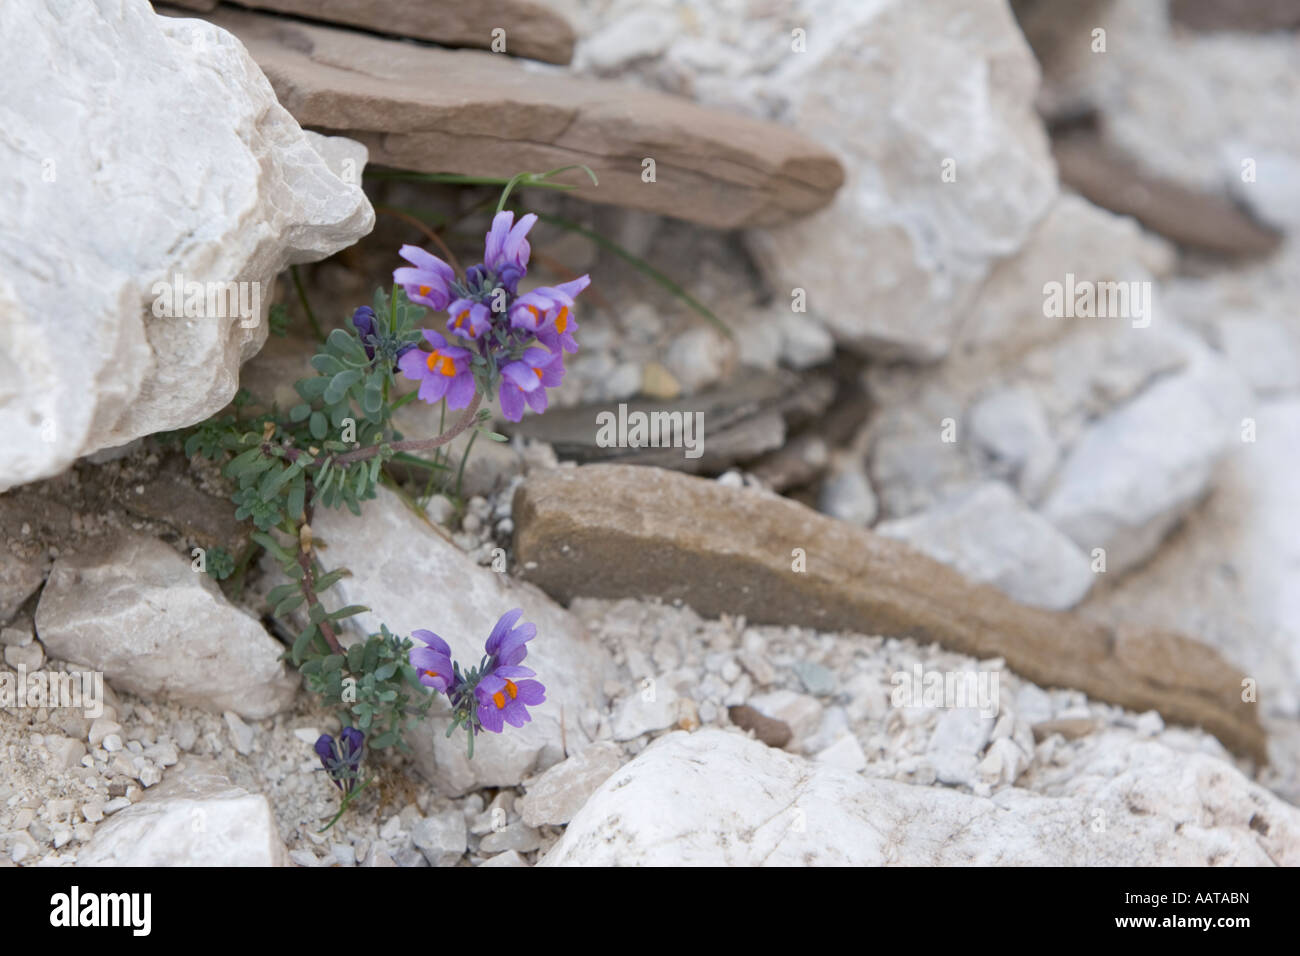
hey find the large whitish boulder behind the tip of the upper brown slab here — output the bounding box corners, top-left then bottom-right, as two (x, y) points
(572, 0), (1057, 359)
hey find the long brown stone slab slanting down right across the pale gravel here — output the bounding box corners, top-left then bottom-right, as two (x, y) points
(514, 464), (1266, 760)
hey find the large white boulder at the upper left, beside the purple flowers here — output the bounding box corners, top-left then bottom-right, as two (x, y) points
(0, 0), (374, 490)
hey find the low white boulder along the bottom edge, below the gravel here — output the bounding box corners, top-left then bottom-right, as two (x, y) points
(541, 730), (1300, 866)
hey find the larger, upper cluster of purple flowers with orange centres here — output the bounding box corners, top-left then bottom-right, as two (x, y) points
(393, 212), (592, 421)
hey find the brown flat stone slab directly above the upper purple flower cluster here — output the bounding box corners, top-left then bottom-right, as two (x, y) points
(192, 7), (844, 229)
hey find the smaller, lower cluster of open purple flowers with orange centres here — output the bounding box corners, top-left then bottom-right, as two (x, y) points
(410, 607), (546, 745)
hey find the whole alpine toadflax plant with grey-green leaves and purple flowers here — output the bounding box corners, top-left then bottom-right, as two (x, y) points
(171, 168), (594, 830)
